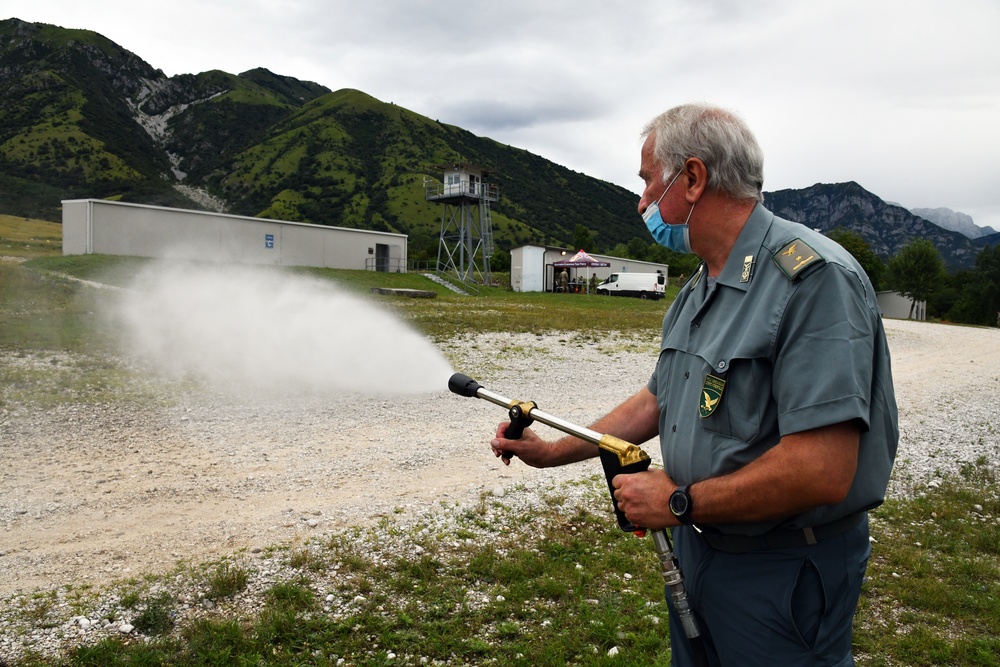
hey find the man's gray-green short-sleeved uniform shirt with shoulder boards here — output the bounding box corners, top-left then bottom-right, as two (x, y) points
(648, 204), (899, 535)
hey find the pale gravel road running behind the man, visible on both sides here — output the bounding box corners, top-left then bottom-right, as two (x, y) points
(0, 321), (1000, 662)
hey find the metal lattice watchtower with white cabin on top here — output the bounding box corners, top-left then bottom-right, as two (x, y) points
(424, 162), (497, 285)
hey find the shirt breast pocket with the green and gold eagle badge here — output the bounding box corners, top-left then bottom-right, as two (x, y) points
(698, 358), (777, 443)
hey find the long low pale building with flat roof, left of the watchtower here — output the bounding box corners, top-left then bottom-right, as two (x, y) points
(62, 199), (408, 273)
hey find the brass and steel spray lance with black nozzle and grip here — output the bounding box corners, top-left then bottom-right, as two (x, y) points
(448, 373), (708, 665)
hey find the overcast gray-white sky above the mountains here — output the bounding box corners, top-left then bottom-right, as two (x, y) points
(7, 0), (1000, 230)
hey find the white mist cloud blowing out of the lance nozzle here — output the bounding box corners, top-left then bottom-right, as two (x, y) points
(112, 263), (451, 394)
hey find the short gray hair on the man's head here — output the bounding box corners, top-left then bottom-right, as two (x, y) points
(642, 104), (764, 202)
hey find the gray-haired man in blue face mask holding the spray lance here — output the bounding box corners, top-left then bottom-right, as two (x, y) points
(491, 105), (898, 667)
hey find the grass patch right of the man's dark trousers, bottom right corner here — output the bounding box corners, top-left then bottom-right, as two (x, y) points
(855, 461), (1000, 666)
